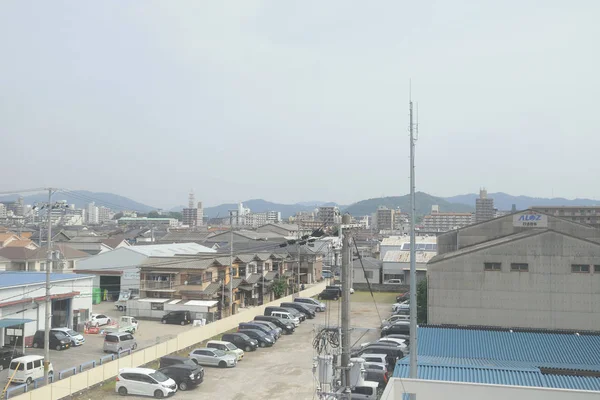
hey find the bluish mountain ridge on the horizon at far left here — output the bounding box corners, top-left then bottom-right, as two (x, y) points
(0, 190), (156, 213)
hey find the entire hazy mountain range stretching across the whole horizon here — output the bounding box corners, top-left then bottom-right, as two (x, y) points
(0, 190), (600, 218)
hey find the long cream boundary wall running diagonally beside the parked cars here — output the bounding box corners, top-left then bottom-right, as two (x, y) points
(9, 282), (326, 400)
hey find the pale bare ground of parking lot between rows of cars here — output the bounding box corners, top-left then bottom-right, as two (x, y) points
(81, 292), (395, 400)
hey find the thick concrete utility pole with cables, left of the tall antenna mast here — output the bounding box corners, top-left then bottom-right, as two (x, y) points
(340, 214), (351, 399)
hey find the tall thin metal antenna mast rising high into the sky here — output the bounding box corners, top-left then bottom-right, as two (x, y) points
(409, 93), (417, 400)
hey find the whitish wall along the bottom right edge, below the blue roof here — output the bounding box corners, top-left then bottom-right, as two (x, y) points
(381, 378), (598, 400)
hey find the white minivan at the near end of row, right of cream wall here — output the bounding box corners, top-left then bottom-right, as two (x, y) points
(115, 368), (177, 399)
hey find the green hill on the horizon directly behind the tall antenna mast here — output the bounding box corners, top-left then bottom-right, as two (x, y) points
(344, 192), (474, 216)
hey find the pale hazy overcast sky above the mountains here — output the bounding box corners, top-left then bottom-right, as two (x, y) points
(0, 0), (600, 207)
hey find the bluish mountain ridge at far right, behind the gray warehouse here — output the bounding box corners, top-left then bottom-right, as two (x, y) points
(444, 192), (600, 210)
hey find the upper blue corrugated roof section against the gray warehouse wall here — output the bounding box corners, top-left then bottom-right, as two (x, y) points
(418, 327), (600, 370)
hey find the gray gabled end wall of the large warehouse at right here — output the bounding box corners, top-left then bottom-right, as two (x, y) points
(428, 231), (600, 330)
